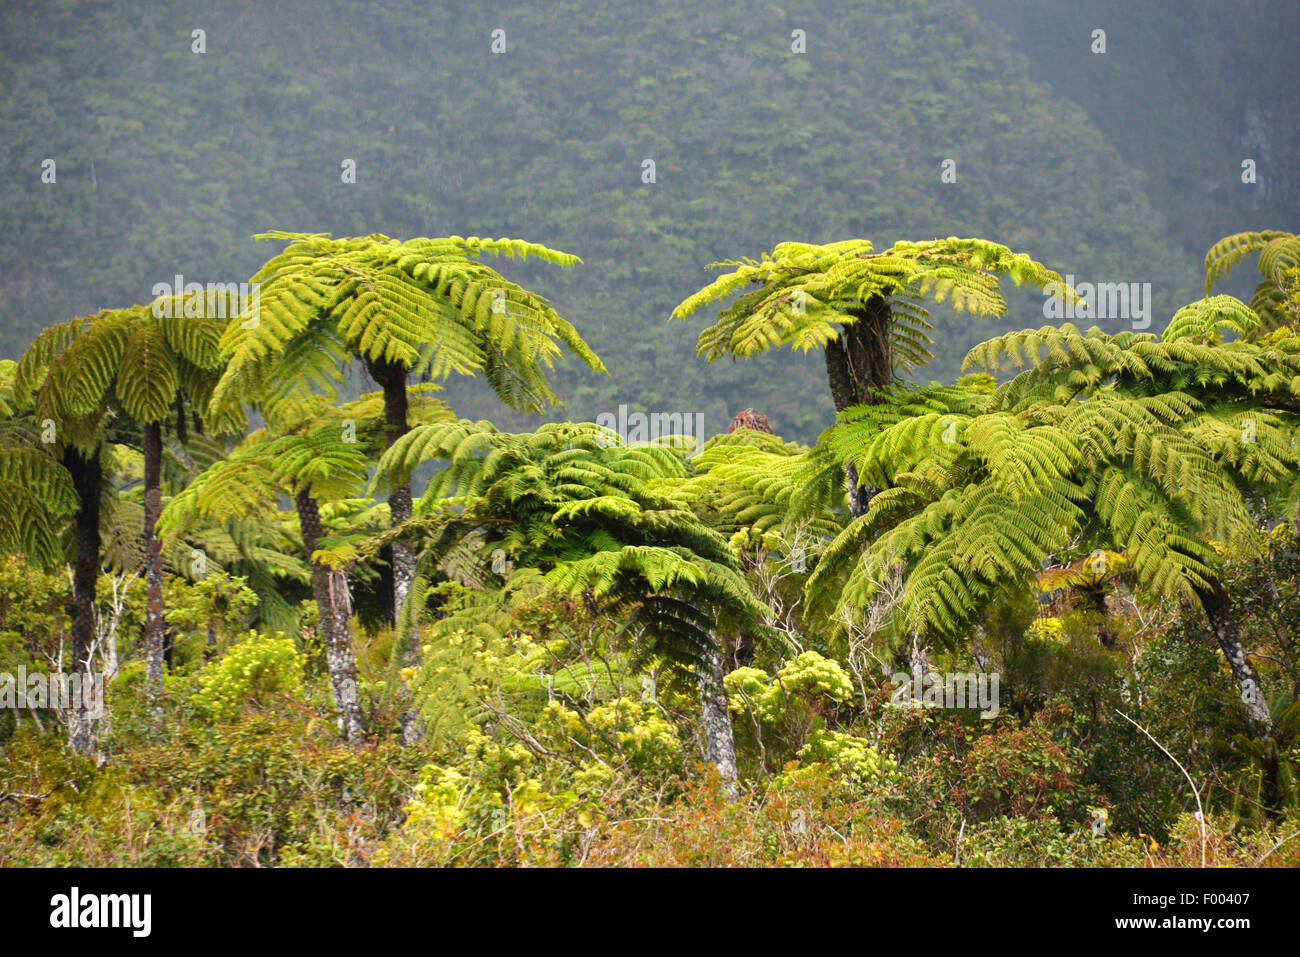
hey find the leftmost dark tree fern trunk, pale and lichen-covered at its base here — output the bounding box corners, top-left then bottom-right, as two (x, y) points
(64, 449), (104, 754)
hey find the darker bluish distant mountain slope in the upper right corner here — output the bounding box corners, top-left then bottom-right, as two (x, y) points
(971, 0), (1300, 261)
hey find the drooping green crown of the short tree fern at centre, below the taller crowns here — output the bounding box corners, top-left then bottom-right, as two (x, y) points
(372, 420), (763, 686)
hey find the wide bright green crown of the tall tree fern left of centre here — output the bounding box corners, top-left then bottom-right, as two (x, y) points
(213, 231), (605, 411)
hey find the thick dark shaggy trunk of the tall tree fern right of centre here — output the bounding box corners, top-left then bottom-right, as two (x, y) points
(826, 296), (893, 519)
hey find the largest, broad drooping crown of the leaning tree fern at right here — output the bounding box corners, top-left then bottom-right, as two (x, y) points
(807, 300), (1300, 647)
